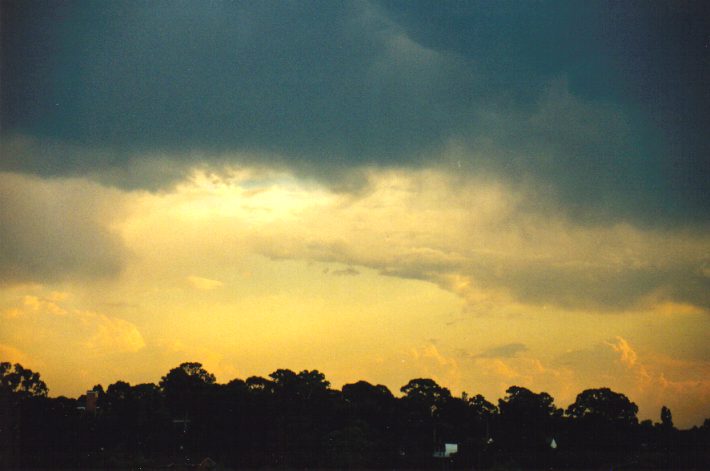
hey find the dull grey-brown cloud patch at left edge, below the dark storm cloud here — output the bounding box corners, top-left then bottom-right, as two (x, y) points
(0, 173), (128, 284)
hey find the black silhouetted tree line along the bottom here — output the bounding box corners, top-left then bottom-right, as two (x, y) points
(0, 362), (710, 469)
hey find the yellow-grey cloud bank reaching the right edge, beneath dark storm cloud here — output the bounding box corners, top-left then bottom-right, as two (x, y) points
(249, 172), (710, 312)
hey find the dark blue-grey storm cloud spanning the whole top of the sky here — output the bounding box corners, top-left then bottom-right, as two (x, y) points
(0, 1), (710, 222)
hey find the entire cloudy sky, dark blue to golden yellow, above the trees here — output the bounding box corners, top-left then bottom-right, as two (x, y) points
(0, 0), (710, 427)
